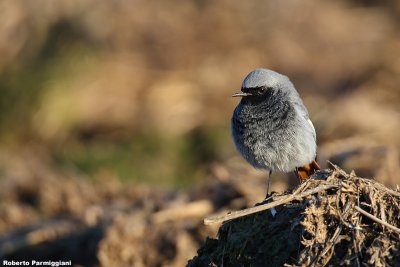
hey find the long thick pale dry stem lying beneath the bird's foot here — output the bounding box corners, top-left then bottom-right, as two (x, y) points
(204, 185), (337, 225)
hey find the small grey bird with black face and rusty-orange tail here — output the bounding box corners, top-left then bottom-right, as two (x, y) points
(231, 69), (320, 193)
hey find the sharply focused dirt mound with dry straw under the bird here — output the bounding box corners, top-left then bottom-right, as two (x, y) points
(188, 167), (400, 267)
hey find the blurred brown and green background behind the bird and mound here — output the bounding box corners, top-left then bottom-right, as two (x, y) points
(0, 0), (400, 266)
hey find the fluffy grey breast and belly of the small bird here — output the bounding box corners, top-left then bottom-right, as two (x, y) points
(232, 100), (316, 172)
